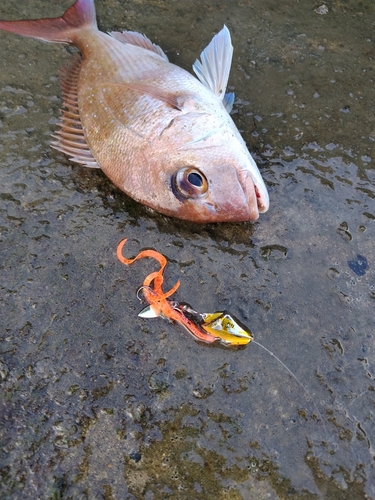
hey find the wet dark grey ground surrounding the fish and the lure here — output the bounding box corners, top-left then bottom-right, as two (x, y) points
(0, 0), (375, 500)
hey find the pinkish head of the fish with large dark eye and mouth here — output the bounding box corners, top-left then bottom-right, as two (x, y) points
(146, 113), (269, 223)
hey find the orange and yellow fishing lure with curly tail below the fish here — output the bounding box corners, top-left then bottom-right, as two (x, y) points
(117, 238), (253, 346)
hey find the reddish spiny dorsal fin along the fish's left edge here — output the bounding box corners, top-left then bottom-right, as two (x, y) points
(51, 55), (100, 168)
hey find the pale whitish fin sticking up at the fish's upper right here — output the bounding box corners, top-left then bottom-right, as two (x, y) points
(193, 26), (233, 99)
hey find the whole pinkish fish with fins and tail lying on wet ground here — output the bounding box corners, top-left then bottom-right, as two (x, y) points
(0, 0), (269, 223)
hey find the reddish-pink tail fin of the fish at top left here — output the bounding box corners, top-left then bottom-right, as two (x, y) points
(0, 0), (97, 43)
